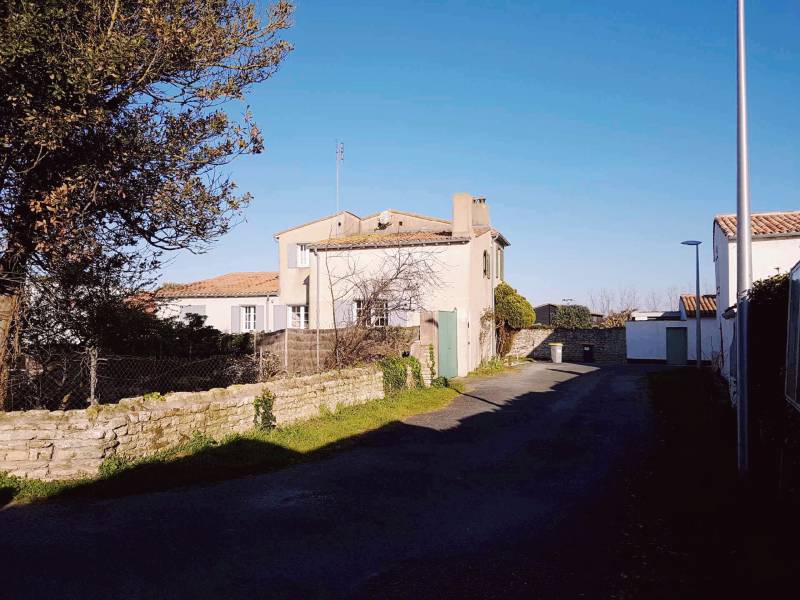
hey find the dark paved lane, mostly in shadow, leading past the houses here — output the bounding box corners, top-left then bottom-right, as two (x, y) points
(0, 363), (650, 599)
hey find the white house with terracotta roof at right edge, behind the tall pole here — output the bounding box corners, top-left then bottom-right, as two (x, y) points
(713, 211), (800, 398)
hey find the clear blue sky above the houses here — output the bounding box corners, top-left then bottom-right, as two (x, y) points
(162, 0), (800, 312)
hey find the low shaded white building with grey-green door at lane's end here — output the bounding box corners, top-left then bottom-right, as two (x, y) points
(625, 294), (720, 365)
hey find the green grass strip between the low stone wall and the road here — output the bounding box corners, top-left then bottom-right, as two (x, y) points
(0, 388), (459, 506)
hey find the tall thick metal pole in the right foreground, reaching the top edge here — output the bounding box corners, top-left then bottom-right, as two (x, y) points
(736, 0), (753, 477)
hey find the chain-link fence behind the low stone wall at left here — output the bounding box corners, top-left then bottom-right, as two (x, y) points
(4, 349), (280, 411)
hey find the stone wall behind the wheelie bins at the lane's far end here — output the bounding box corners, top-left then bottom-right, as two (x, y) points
(509, 327), (627, 364)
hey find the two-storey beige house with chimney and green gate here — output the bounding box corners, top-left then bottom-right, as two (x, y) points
(274, 193), (509, 376)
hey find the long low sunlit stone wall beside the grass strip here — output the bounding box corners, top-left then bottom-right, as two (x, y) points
(0, 367), (384, 480)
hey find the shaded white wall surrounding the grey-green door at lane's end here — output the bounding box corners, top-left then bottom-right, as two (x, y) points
(625, 318), (720, 361)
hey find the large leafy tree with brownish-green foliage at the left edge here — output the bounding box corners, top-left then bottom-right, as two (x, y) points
(0, 0), (293, 404)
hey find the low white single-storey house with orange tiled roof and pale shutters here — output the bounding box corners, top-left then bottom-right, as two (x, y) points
(156, 271), (279, 333)
